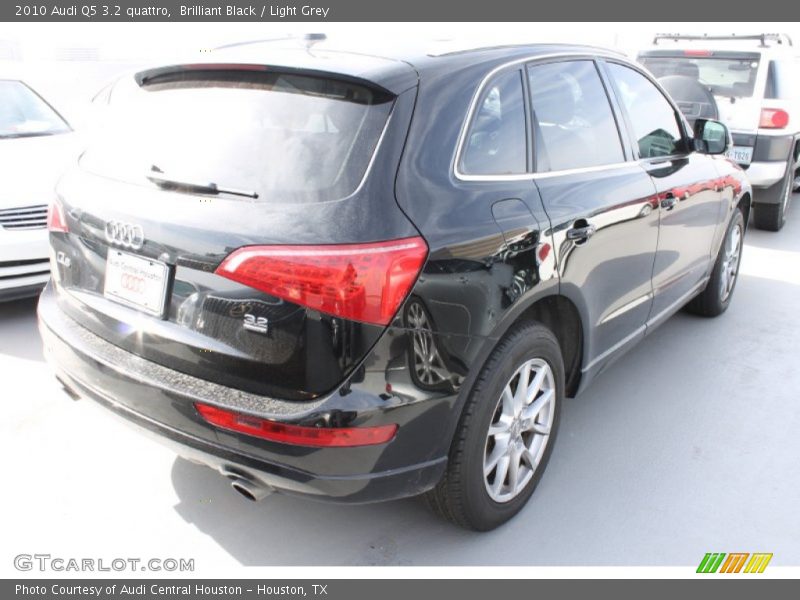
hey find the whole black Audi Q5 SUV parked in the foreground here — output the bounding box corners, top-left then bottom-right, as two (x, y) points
(39, 41), (751, 530)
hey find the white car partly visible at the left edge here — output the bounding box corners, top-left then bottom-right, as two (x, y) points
(0, 78), (75, 301)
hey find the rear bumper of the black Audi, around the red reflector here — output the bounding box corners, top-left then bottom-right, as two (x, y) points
(39, 284), (455, 503)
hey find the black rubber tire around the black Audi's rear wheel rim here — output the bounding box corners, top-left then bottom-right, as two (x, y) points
(426, 322), (564, 531)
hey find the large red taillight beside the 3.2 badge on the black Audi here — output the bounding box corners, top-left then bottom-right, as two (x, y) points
(216, 237), (428, 325)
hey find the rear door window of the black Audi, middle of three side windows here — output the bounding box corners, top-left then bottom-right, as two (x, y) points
(528, 60), (624, 171)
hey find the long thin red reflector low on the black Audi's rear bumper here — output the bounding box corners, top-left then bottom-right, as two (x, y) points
(194, 403), (397, 448)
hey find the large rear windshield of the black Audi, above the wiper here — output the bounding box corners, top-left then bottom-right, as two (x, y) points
(81, 70), (393, 202)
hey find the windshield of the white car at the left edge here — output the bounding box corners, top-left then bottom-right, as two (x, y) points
(0, 80), (70, 138)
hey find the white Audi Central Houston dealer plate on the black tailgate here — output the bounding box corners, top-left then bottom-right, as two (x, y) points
(103, 249), (169, 317)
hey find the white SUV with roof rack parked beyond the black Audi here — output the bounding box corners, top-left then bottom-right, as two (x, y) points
(638, 33), (800, 231)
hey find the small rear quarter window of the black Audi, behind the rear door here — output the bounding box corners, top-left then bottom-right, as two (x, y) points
(460, 71), (528, 175)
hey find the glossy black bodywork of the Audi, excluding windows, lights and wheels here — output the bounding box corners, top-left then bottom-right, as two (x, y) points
(39, 39), (749, 502)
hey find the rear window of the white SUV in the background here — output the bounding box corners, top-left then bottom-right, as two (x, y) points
(639, 55), (759, 98)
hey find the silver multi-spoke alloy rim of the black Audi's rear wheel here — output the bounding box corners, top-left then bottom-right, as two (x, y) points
(483, 358), (556, 503)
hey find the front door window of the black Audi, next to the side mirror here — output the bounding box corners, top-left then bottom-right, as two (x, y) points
(608, 63), (683, 158)
